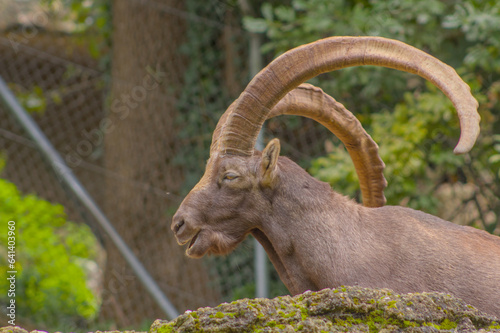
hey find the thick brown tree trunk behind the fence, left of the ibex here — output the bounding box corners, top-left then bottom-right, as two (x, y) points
(101, 0), (219, 327)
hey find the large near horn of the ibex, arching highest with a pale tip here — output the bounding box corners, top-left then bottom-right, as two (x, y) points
(213, 37), (480, 156)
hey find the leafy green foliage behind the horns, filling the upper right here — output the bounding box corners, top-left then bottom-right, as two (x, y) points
(244, 0), (500, 232)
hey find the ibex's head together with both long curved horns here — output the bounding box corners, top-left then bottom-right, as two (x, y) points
(172, 37), (479, 258)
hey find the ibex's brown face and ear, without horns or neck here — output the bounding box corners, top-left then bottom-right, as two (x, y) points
(172, 140), (279, 258)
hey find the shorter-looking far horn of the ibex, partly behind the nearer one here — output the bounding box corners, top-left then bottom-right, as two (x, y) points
(268, 84), (387, 207)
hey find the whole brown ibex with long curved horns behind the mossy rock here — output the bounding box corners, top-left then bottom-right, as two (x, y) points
(172, 37), (500, 317)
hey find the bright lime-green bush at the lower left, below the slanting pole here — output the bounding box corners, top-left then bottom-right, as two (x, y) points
(0, 179), (98, 328)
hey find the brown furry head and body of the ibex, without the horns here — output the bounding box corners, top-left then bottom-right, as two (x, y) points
(172, 140), (500, 317)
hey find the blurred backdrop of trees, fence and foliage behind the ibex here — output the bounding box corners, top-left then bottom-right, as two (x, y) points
(0, 0), (500, 332)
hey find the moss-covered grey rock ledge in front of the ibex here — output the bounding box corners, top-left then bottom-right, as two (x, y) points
(150, 287), (500, 333)
